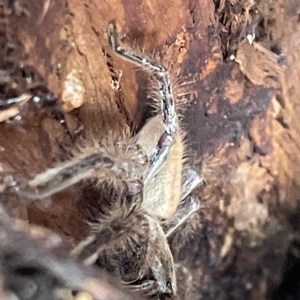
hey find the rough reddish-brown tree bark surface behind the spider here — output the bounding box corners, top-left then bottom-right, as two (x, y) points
(0, 0), (300, 300)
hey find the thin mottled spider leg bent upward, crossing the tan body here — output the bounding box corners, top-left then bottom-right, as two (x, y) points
(108, 23), (178, 181)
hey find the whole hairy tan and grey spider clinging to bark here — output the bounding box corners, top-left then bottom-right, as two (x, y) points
(7, 23), (202, 295)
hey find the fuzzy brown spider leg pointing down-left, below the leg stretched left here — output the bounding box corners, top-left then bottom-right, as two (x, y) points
(71, 197), (149, 266)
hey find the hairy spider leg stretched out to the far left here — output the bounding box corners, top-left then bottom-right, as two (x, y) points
(7, 147), (146, 199)
